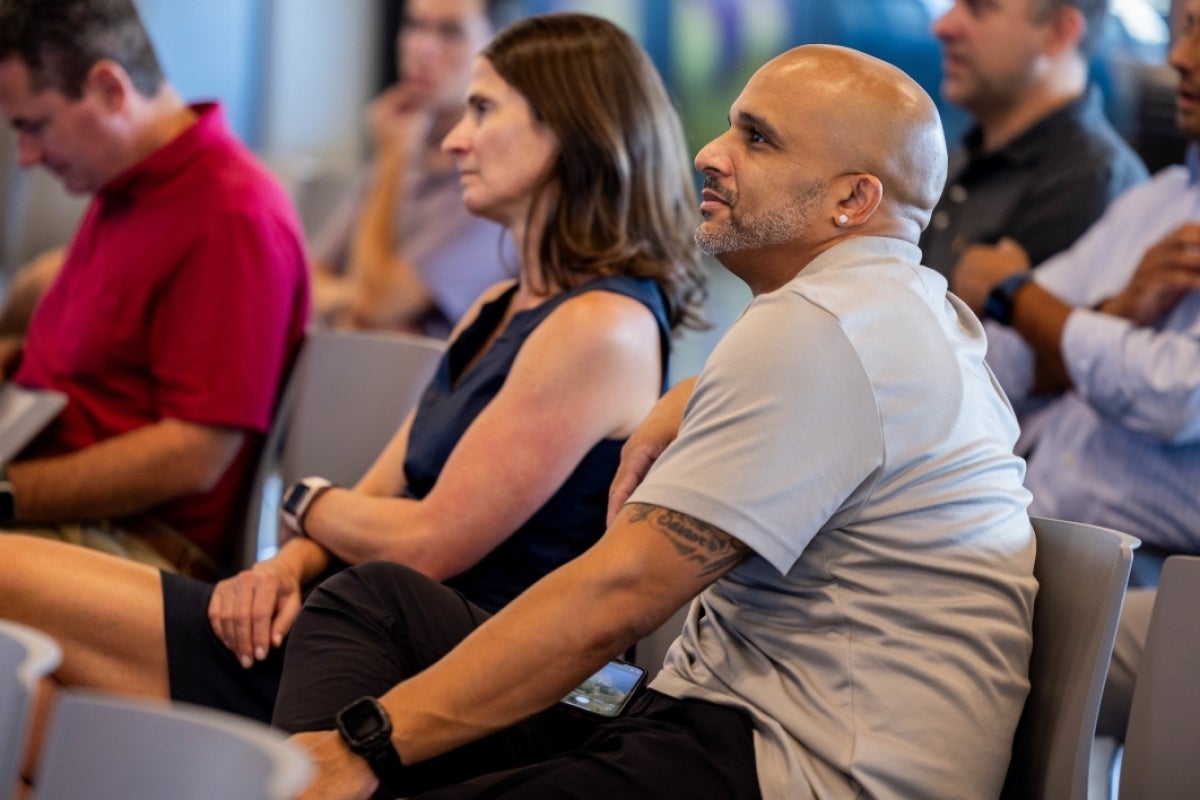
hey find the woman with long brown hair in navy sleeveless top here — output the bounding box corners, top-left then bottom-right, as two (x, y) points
(0, 14), (703, 734)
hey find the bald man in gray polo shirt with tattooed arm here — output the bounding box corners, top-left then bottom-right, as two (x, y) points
(275, 46), (1034, 800)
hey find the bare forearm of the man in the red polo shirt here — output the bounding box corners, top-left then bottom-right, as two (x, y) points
(8, 420), (245, 522)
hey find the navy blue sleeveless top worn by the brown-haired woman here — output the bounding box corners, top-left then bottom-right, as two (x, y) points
(404, 276), (671, 612)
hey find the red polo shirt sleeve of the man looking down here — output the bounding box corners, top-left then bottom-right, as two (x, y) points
(151, 209), (307, 432)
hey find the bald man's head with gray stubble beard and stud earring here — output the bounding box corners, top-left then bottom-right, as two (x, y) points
(696, 44), (946, 294)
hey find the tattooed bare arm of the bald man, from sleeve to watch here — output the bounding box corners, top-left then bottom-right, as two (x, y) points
(383, 504), (749, 763)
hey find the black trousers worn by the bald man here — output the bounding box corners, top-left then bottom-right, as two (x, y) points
(274, 563), (760, 800)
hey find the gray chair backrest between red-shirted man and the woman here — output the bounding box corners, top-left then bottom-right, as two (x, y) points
(241, 330), (445, 566)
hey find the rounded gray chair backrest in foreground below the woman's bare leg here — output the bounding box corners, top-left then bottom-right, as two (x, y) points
(35, 691), (313, 800)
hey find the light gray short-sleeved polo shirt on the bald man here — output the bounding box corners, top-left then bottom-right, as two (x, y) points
(631, 239), (1036, 800)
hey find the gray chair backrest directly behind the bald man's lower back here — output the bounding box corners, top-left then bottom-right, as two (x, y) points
(1001, 517), (1140, 800)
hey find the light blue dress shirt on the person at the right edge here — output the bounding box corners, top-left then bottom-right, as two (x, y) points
(988, 145), (1200, 552)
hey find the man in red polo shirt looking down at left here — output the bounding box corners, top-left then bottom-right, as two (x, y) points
(0, 0), (308, 575)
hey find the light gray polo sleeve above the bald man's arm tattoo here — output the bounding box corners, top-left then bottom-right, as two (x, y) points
(630, 289), (883, 573)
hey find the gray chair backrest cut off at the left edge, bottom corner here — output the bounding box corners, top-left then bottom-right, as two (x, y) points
(0, 620), (62, 799)
